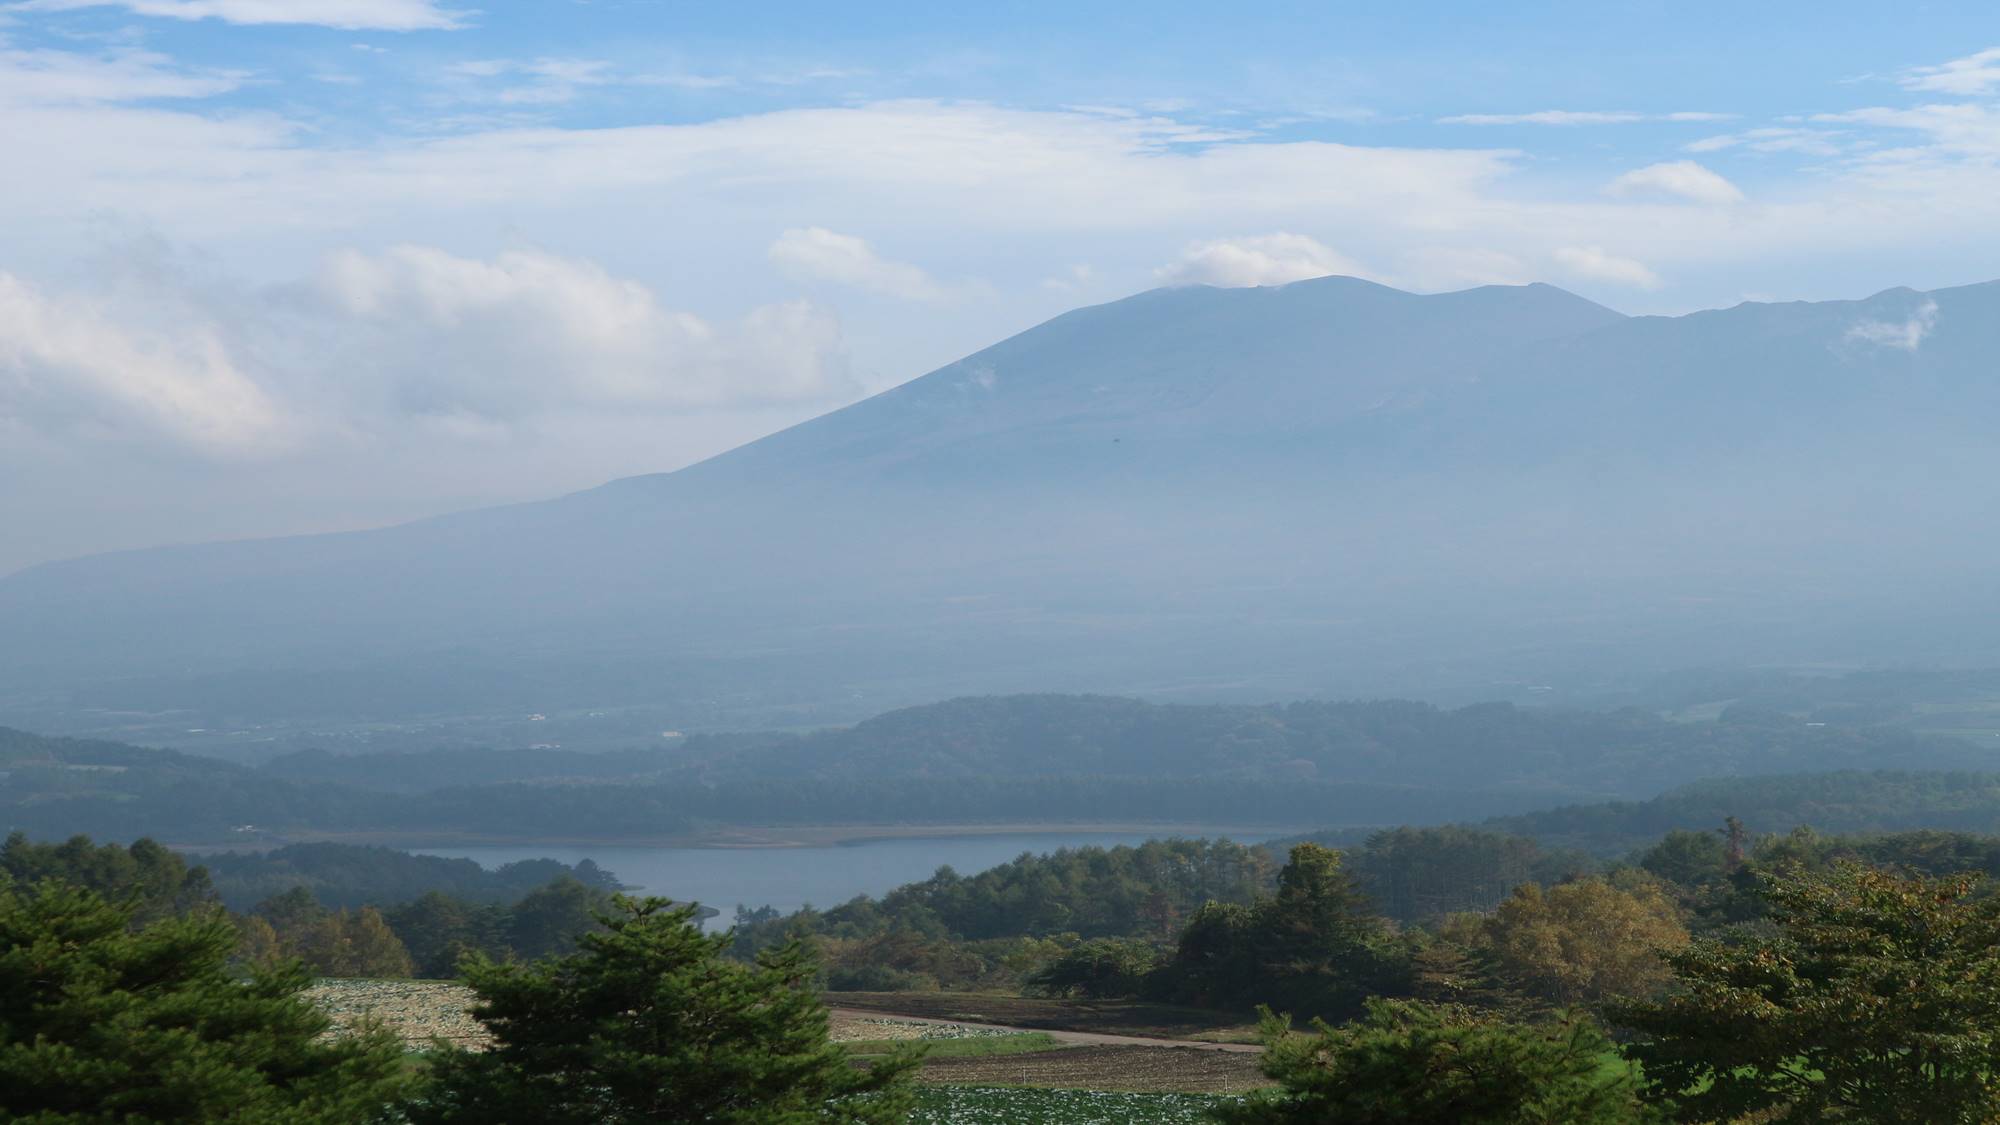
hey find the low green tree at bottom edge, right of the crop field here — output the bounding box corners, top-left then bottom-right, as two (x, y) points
(1218, 999), (1656, 1125)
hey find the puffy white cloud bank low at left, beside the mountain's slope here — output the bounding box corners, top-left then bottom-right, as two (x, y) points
(0, 246), (856, 458)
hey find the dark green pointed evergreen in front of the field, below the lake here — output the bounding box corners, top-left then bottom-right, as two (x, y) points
(426, 895), (918, 1125)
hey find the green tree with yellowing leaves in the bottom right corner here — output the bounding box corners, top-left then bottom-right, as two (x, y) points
(1614, 863), (2000, 1125)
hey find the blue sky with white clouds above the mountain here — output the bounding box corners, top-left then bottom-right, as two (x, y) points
(0, 0), (2000, 573)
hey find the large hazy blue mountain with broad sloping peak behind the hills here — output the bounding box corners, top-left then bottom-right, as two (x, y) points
(11, 278), (2000, 731)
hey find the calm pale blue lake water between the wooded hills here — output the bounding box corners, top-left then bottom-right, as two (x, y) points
(412, 829), (1270, 925)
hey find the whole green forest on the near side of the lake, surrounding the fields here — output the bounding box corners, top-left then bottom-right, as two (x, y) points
(19, 819), (2000, 1125)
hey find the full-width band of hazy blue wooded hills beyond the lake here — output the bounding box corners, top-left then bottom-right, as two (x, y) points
(15, 695), (1996, 843)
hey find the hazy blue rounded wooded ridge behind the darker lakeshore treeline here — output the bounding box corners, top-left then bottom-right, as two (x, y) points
(702, 695), (2000, 797)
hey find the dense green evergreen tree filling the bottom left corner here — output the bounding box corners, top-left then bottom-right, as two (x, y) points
(0, 881), (406, 1125)
